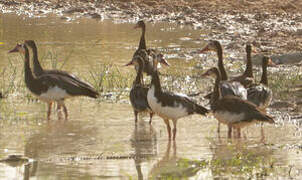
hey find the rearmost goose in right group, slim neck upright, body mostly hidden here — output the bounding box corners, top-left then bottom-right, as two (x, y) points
(232, 44), (254, 88)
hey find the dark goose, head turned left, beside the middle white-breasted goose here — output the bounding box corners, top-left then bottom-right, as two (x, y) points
(126, 56), (153, 124)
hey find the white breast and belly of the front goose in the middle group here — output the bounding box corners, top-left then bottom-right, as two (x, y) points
(147, 85), (188, 119)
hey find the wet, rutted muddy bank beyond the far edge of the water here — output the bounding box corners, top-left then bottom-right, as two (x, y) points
(0, 0), (302, 54)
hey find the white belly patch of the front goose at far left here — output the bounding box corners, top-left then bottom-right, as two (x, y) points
(39, 86), (71, 101)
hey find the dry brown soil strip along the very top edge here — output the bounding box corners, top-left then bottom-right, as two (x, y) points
(6, 0), (302, 13)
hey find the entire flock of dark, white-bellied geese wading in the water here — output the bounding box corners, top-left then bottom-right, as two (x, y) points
(9, 21), (274, 140)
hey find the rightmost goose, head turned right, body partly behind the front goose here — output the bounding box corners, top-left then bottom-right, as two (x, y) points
(247, 56), (273, 110)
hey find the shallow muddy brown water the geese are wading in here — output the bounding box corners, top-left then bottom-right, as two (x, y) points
(0, 15), (302, 179)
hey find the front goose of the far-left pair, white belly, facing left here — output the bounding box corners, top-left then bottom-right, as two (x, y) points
(9, 44), (98, 120)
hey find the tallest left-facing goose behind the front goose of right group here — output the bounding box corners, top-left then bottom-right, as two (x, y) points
(200, 40), (247, 133)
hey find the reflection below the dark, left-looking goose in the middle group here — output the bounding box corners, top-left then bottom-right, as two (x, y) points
(131, 120), (158, 180)
